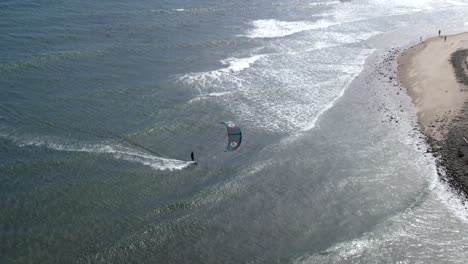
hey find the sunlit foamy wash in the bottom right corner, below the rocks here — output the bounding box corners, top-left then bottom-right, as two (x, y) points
(293, 166), (468, 264)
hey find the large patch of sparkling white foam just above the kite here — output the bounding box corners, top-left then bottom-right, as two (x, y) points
(180, 46), (372, 133)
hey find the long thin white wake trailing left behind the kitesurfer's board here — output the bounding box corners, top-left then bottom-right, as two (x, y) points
(0, 135), (190, 170)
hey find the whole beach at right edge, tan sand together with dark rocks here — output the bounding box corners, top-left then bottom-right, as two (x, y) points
(397, 33), (468, 198)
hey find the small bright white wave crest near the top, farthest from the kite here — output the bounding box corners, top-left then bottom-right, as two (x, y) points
(245, 19), (339, 38)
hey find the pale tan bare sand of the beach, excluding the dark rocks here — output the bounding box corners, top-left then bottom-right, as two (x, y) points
(398, 33), (468, 140)
